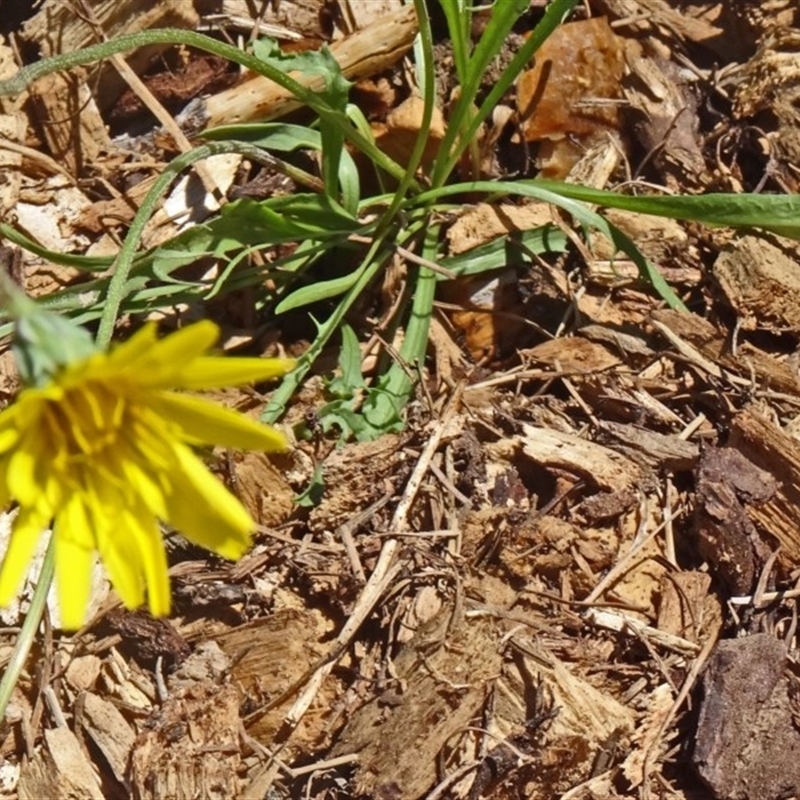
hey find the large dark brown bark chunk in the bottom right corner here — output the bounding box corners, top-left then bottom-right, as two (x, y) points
(692, 634), (800, 800)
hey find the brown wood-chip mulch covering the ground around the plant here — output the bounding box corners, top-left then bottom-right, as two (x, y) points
(0, 0), (800, 800)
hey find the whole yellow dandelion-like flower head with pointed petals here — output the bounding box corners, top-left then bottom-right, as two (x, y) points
(0, 322), (292, 629)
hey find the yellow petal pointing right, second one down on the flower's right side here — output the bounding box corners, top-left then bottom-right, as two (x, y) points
(152, 392), (288, 452)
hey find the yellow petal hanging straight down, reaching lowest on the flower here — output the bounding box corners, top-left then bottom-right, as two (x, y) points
(53, 492), (96, 631)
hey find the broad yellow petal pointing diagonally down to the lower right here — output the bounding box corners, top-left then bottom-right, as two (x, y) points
(166, 444), (250, 560)
